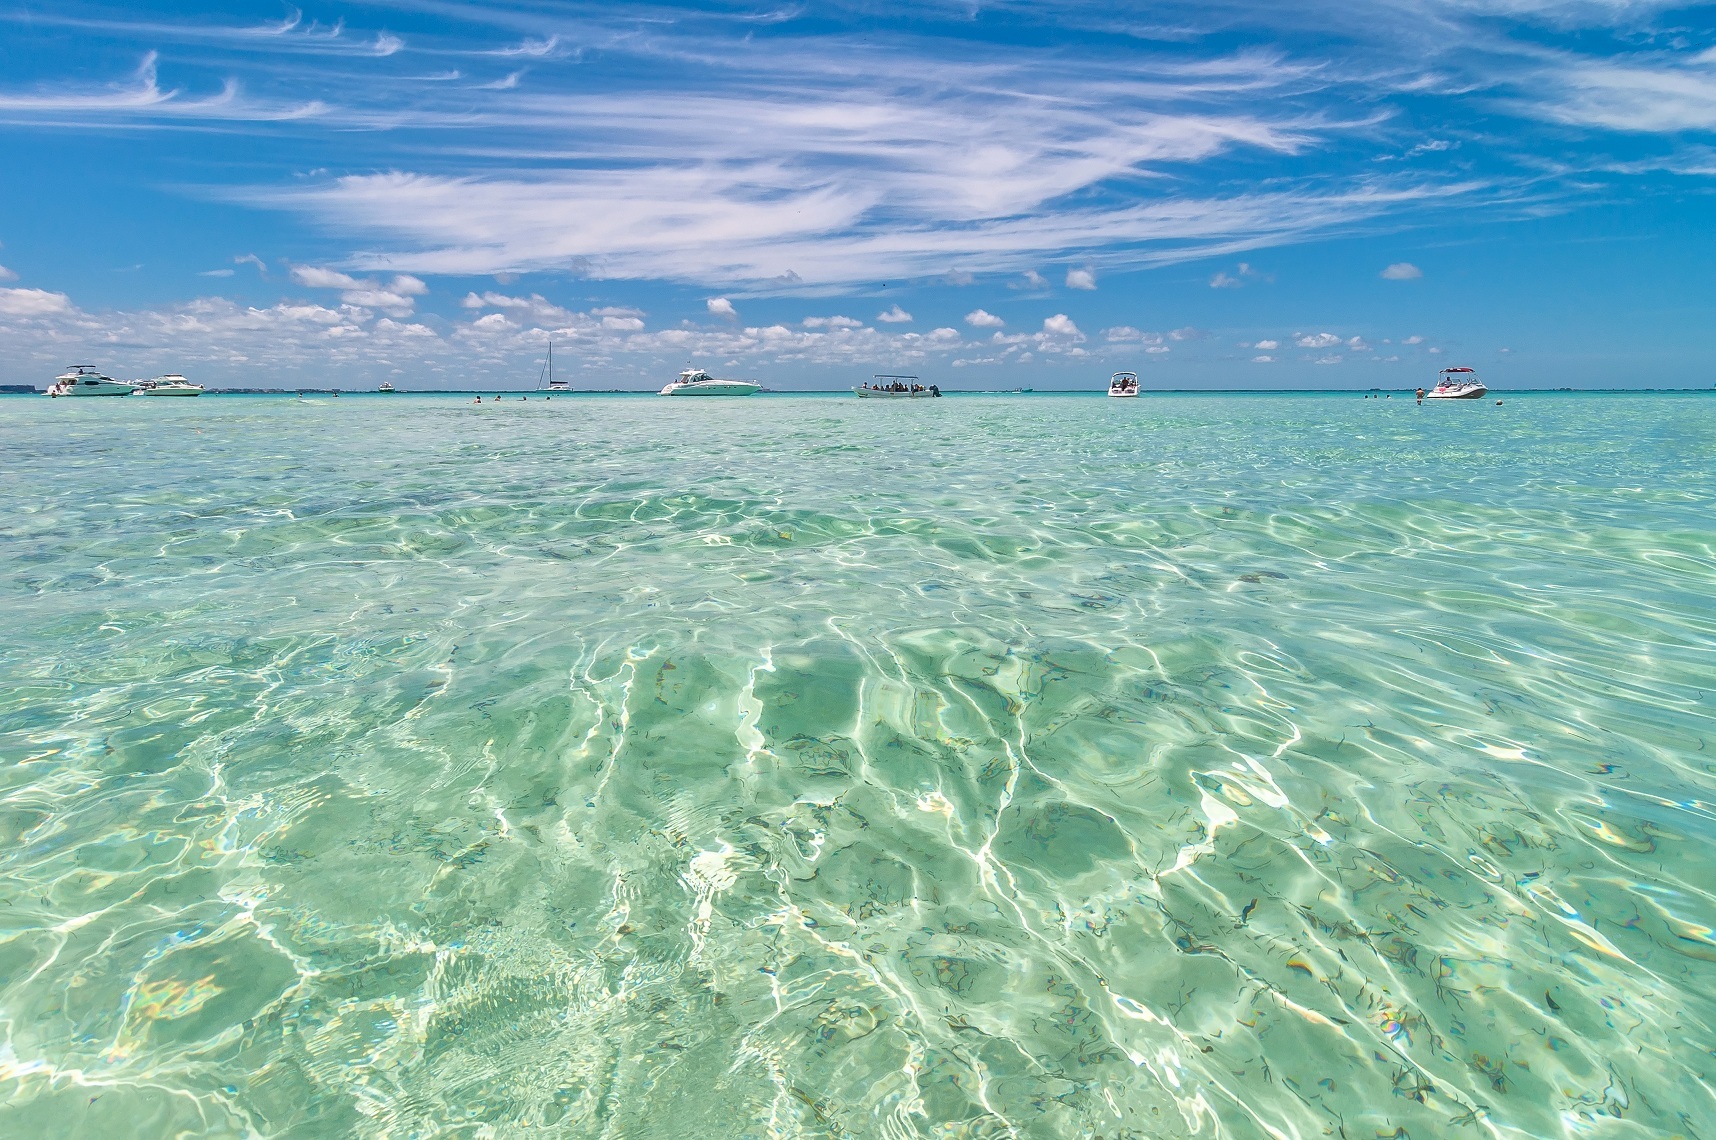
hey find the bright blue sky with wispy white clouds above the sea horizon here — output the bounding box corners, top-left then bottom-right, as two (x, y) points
(0, 0), (1716, 390)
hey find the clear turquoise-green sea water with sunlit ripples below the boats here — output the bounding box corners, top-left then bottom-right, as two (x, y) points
(0, 395), (1716, 1140)
